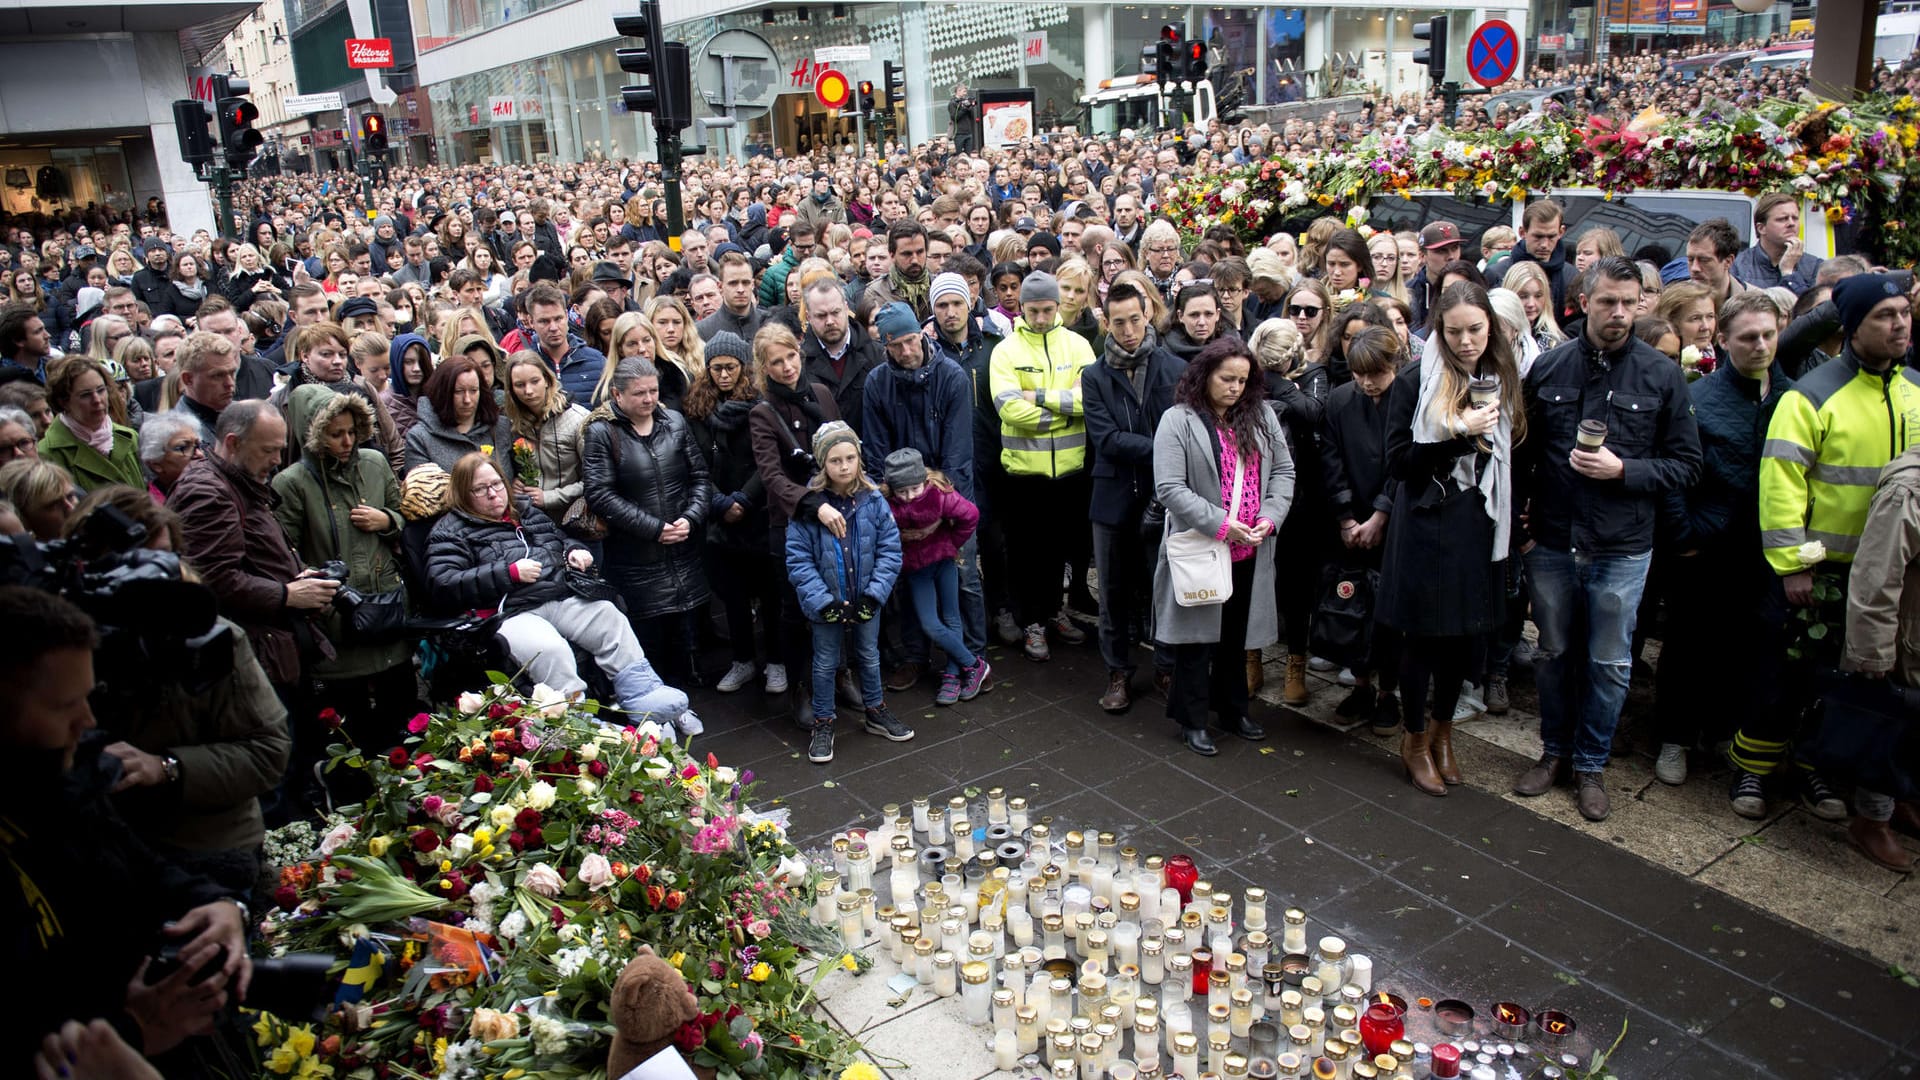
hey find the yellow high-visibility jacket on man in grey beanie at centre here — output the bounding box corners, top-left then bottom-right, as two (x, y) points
(987, 319), (1096, 477)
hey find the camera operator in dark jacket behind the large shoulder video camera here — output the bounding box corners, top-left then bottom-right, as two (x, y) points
(65, 484), (290, 896)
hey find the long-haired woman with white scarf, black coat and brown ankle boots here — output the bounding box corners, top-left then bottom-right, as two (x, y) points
(1377, 284), (1526, 796)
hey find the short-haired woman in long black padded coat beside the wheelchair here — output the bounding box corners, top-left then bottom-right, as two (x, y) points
(580, 357), (712, 691)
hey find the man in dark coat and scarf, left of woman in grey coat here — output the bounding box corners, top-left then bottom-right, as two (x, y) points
(1081, 284), (1187, 713)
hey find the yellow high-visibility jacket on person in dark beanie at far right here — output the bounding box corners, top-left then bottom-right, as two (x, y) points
(1761, 348), (1920, 577)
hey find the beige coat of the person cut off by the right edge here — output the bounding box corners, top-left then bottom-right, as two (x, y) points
(1841, 444), (1920, 686)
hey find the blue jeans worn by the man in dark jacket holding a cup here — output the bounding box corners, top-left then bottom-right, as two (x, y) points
(1526, 546), (1653, 773)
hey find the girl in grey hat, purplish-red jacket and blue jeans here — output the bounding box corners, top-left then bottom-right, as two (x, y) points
(885, 446), (993, 705)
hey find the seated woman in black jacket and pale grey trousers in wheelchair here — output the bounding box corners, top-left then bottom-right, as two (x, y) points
(426, 445), (703, 736)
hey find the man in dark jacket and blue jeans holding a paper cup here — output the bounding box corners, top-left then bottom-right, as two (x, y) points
(1513, 256), (1701, 821)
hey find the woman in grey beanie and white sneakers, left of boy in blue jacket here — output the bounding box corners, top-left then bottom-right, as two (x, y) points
(682, 331), (787, 694)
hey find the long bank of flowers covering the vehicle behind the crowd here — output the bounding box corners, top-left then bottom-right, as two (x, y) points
(1162, 94), (1920, 263)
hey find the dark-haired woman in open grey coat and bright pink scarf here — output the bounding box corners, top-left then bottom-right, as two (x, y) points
(1154, 336), (1294, 757)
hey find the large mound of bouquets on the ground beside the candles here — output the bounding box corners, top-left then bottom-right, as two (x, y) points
(255, 676), (868, 1080)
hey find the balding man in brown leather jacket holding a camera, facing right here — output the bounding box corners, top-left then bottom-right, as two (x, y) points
(167, 400), (340, 819)
